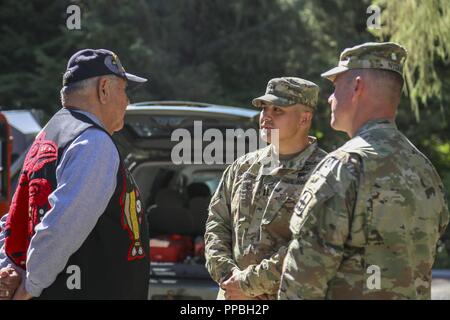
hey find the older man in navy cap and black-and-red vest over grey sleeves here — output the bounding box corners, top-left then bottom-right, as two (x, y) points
(0, 49), (149, 299)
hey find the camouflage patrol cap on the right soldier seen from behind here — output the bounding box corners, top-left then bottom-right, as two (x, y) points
(321, 42), (408, 81)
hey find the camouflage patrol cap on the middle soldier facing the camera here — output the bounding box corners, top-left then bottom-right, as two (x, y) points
(252, 77), (319, 109)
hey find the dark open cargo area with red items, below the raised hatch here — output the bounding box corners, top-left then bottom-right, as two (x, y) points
(133, 162), (225, 299)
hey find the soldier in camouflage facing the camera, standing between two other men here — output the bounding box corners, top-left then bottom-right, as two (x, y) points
(205, 77), (326, 299)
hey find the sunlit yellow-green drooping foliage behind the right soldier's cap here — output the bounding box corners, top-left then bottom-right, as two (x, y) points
(374, 0), (450, 120)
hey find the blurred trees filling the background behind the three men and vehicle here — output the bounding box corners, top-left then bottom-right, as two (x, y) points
(0, 0), (450, 268)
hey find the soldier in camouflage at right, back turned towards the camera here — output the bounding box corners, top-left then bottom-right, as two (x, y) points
(279, 43), (449, 299)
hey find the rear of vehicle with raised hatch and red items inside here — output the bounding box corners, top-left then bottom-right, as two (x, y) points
(114, 101), (259, 300)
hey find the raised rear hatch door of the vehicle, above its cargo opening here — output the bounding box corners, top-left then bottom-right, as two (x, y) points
(113, 102), (258, 169)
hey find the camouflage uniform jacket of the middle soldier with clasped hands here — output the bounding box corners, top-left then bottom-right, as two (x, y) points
(205, 137), (326, 298)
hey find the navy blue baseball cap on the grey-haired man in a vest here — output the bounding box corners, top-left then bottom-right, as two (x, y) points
(63, 49), (147, 86)
